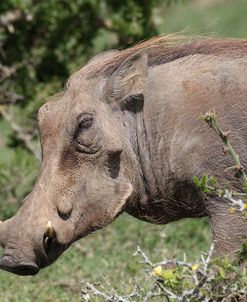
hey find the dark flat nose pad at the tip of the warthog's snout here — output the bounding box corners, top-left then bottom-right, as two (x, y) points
(0, 257), (39, 276)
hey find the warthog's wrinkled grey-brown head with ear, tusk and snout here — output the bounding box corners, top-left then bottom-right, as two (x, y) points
(0, 51), (147, 275)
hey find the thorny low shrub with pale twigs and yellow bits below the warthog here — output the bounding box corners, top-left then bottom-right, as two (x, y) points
(82, 245), (247, 302)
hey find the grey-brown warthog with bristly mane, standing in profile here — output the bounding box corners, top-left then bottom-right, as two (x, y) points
(0, 36), (247, 275)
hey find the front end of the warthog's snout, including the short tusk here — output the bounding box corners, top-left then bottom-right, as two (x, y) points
(0, 219), (64, 276)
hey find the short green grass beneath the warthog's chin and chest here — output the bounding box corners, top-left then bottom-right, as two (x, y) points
(0, 214), (210, 302)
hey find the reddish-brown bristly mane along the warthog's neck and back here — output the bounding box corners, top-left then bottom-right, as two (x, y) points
(78, 35), (247, 78)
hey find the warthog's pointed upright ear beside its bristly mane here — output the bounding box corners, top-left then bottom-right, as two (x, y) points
(106, 50), (148, 102)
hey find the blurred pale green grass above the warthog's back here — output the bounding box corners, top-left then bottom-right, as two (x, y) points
(157, 0), (247, 38)
